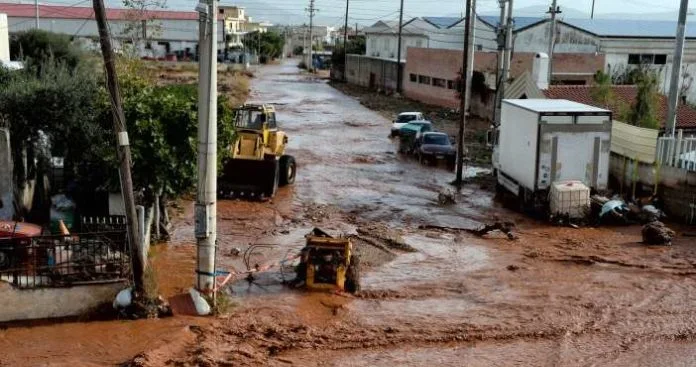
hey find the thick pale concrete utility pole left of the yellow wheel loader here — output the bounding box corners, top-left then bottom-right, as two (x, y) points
(195, 0), (217, 292)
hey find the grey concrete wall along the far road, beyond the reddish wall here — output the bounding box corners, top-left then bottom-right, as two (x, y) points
(346, 55), (398, 91)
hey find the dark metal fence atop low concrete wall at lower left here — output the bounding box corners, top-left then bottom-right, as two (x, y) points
(0, 231), (130, 288)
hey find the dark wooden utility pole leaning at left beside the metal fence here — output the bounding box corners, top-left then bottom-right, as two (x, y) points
(92, 0), (145, 295)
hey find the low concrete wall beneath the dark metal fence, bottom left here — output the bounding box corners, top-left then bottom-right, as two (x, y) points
(0, 282), (127, 322)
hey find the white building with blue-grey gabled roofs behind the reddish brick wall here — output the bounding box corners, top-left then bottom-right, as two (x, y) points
(364, 17), (497, 60)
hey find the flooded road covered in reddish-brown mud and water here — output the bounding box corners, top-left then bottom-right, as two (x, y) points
(0, 64), (696, 366)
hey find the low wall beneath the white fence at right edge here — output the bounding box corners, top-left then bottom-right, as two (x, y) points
(609, 154), (696, 222)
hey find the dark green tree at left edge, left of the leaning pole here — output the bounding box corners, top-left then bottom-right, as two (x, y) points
(0, 59), (103, 220)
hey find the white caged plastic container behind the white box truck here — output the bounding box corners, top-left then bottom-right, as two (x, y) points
(549, 181), (590, 219)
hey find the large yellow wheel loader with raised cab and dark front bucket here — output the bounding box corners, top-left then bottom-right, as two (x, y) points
(218, 104), (297, 200)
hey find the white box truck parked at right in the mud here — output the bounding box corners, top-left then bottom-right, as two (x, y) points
(493, 99), (612, 209)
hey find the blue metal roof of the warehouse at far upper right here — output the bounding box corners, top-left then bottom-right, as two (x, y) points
(561, 19), (696, 38)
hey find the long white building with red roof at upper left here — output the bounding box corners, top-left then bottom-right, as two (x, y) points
(0, 3), (223, 57)
